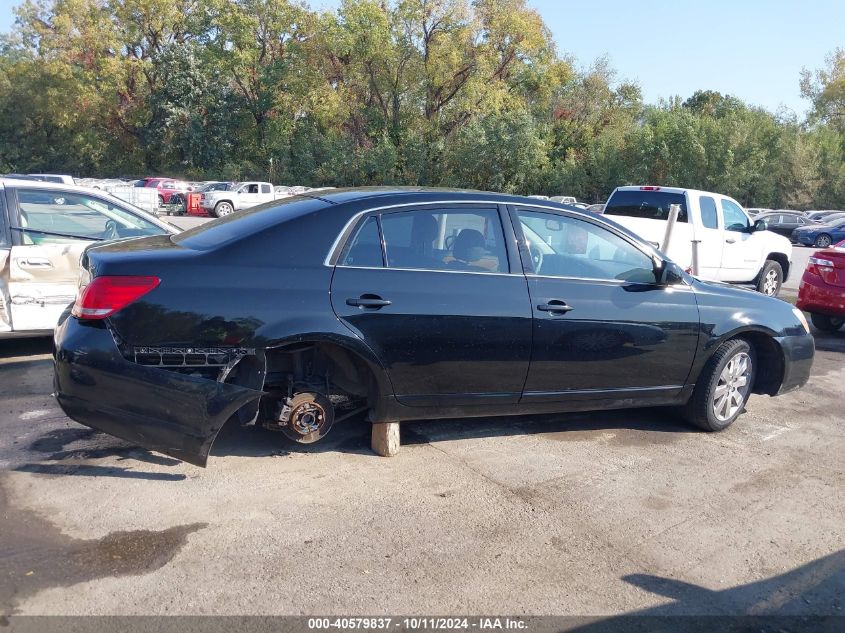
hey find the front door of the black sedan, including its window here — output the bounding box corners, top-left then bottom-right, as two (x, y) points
(511, 207), (699, 403)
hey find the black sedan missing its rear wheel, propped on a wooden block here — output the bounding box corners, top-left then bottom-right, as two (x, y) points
(55, 189), (814, 466)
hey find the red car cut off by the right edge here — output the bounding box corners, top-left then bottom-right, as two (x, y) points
(796, 240), (845, 332)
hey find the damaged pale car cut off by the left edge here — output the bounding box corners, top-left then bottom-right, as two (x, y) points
(0, 179), (177, 338)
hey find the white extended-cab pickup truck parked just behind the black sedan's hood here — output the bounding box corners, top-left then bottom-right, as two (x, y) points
(604, 187), (792, 296)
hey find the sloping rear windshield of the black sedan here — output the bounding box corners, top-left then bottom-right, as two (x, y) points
(172, 197), (331, 251)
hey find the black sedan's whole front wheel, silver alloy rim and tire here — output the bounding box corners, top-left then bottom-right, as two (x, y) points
(685, 339), (756, 431)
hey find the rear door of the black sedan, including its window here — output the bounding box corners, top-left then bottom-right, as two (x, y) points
(331, 204), (532, 406)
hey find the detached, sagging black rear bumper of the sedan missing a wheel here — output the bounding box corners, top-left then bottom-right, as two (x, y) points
(54, 317), (262, 466)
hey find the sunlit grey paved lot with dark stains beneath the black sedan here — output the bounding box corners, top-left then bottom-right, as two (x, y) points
(0, 326), (845, 615)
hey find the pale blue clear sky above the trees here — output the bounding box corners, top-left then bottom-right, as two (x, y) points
(0, 0), (845, 116)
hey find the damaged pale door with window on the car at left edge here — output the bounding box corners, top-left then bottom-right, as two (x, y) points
(6, 187), (164, 331)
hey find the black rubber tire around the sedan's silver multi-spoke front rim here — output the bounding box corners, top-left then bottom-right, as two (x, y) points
(684, 339), (757, 431)
